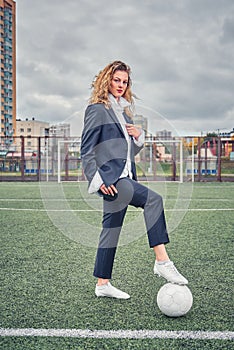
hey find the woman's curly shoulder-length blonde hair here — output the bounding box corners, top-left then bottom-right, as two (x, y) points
(89, 61), (133, 108)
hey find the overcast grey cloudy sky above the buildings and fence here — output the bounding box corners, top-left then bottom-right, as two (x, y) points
(16, 0), (234, 135)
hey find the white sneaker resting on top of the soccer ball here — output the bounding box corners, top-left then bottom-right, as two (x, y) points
(154, 261), (188, 285)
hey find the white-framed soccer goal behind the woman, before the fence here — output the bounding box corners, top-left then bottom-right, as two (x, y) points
(57, 137), (186, 183)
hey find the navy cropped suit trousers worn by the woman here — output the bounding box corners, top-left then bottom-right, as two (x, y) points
(93, 178), (169, 279)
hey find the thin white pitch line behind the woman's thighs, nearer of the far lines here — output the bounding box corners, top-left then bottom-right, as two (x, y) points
(0, 208), (234, 212)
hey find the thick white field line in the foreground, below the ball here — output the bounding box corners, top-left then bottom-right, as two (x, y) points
(0, 328), (234, 340)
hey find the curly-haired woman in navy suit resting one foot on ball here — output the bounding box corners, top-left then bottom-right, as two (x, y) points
(81, 61), (188, 299)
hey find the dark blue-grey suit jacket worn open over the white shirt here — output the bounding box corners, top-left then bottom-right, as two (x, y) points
(81, 103), (143, 186)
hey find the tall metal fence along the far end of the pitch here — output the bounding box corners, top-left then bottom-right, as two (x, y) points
(0, 136), (234, 182)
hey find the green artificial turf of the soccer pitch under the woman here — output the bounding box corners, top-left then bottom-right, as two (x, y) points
(0, 183), (234, 349)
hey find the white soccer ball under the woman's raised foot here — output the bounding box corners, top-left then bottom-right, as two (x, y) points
(157, 283), (193, 317)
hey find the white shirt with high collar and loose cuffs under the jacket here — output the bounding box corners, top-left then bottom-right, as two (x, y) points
(88, 94), (145, 193)
